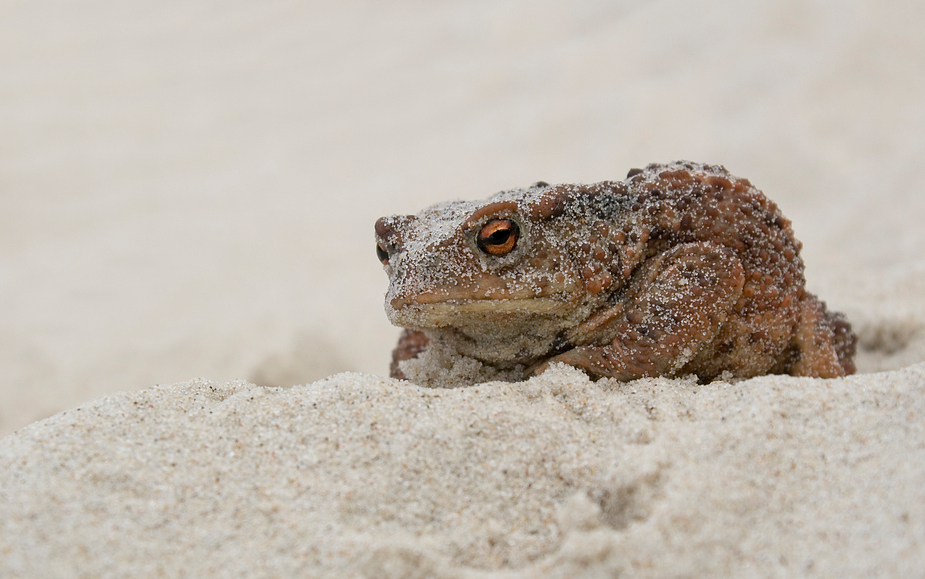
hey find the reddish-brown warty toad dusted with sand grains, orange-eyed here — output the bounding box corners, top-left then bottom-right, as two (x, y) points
(376, 162), (856, 381)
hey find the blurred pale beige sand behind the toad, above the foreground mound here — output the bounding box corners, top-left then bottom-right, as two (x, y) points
(0, 0), (925, 435)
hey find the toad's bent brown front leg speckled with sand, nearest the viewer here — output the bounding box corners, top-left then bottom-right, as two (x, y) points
(535, 242), (745, 380)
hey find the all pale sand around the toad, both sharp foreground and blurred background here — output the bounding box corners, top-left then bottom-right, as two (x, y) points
(0, 0), (925, 577)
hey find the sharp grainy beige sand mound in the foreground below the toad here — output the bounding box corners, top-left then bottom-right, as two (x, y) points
(0, 364), (925, 578)
